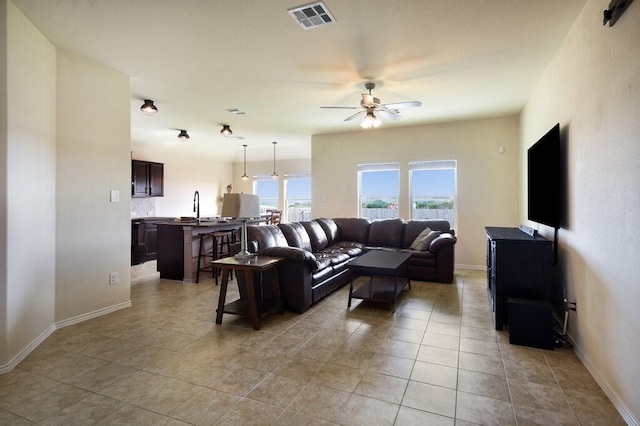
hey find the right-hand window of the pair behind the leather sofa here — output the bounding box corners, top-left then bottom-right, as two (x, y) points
(409, 160), (456, 228)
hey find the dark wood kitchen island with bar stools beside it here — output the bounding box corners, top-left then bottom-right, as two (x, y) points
(157, 219), (242, 283)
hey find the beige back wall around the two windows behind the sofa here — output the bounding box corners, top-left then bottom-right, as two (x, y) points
(311, 115), (519, 268)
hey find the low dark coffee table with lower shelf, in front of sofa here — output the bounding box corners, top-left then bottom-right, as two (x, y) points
(347, 250), (411, 313)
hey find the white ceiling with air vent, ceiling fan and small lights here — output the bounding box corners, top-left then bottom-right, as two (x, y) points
(13, 0), (584, 161)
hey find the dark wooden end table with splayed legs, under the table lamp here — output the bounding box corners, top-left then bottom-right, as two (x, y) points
(211, 256), (285, 330)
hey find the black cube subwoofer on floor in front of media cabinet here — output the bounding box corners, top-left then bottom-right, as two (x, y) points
(507, 297), (555, 350)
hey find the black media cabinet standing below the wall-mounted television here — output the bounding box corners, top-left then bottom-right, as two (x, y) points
(485, 226), (553, 330)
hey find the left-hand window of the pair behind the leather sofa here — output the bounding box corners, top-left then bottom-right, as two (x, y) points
(358, 163), (400, 219)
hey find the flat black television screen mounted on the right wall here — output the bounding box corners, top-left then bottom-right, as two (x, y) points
(527, 123), (562, 229)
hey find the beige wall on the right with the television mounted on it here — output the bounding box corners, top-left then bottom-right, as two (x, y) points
(520, 1), (640, 424)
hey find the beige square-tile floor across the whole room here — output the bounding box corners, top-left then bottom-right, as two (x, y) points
(0, 262), (625, 426)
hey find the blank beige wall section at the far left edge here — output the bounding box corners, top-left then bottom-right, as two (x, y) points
(0, 1), (56, 371)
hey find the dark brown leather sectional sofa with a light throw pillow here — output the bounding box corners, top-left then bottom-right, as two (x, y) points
(239, 218), (457, 313)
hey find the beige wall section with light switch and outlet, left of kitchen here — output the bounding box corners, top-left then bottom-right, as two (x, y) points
(56, 51), (131, 322)
